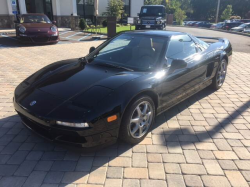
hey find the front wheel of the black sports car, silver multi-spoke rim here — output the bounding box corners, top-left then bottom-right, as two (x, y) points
(119, 96), (155, 144)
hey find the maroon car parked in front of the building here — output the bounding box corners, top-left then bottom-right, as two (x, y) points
(16, 14), (59, 44)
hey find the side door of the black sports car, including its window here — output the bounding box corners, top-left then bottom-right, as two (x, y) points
(158, 35), (206, 110)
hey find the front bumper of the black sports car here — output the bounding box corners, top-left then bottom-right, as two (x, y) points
(14, 101), (119, 151)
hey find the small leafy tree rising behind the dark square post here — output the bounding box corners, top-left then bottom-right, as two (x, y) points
(103, 0), (124, 18)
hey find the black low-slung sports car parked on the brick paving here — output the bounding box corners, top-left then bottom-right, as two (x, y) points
(14, 31), (232, 148)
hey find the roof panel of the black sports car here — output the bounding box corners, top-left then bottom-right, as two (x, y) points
(124, 30), (187, 38)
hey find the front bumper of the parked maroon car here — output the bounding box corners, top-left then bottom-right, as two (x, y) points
(18, 35), (59, 44)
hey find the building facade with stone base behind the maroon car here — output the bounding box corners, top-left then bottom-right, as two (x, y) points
(0, 0), (144, 28)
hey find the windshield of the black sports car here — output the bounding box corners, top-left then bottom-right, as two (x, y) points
(87, 34), (167, 71)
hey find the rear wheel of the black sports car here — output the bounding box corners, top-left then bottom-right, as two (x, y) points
(211, 59), (227, 90)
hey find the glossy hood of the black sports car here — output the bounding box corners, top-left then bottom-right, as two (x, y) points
(17, 59), (142, 100)
